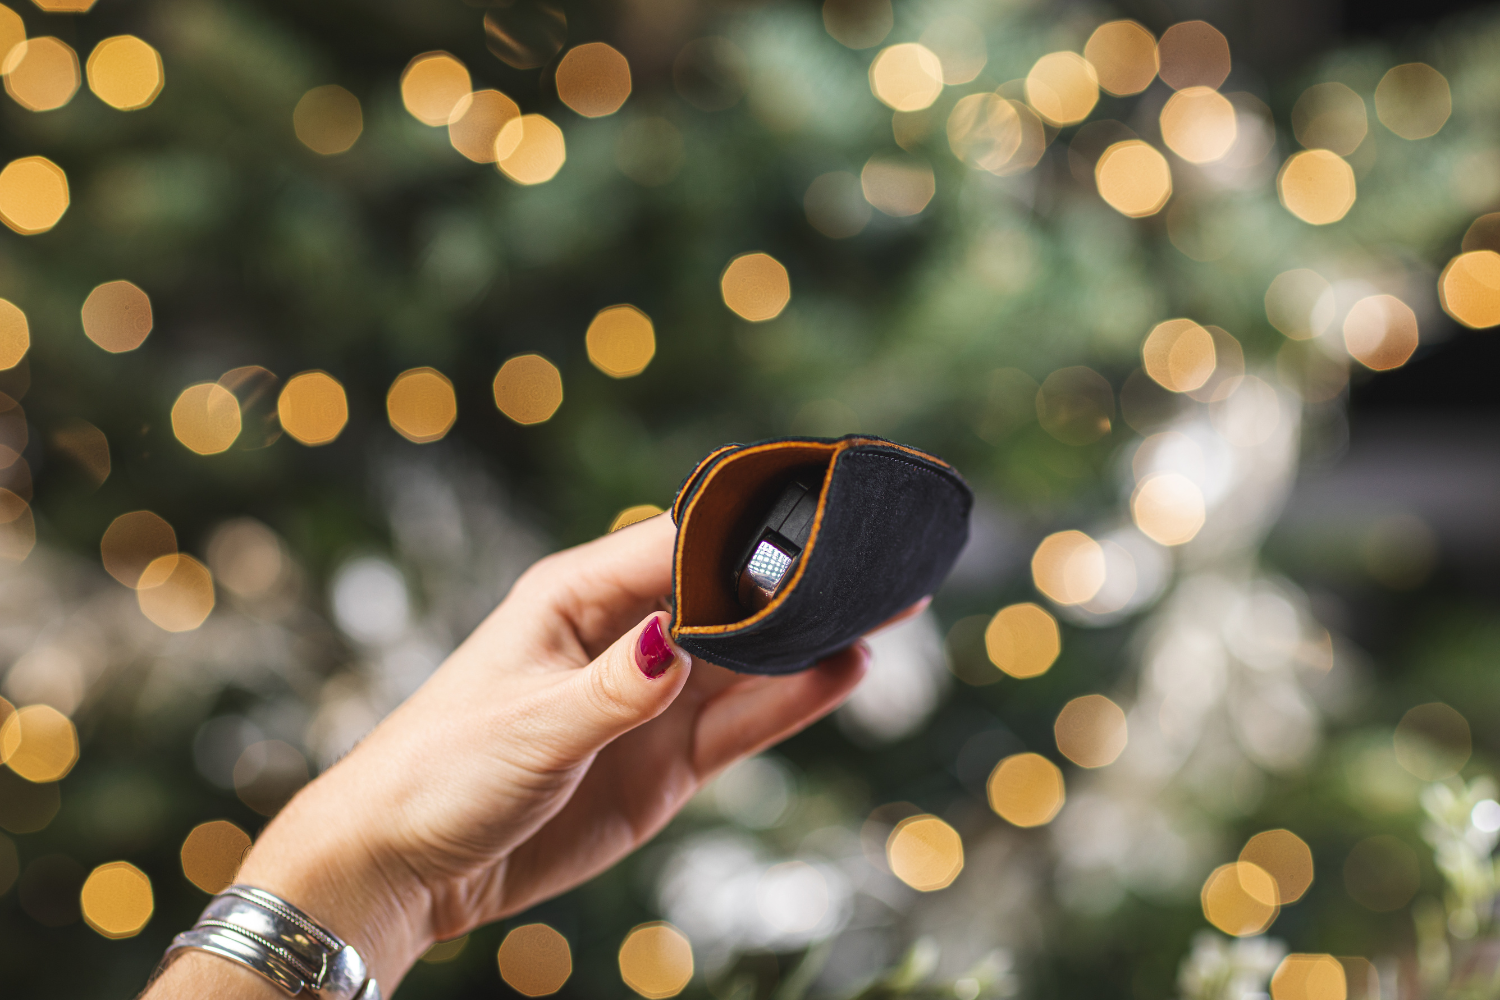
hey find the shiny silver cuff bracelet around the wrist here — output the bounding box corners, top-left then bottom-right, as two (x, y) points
(152, 885), (381, 1000)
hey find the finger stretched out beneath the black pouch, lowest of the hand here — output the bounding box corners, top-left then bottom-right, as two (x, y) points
(693, 643), (870, 778)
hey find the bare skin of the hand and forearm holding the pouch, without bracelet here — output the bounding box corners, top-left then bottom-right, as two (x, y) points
(146, 514), (926, 999)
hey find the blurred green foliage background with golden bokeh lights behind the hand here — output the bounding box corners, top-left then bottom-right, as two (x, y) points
(0, 0), (1500, 1000)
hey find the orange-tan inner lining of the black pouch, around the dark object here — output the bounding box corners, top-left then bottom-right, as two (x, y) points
(672, 441), (846, 636)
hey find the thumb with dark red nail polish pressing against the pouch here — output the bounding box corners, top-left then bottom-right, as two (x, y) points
(557, 612), (693, 760)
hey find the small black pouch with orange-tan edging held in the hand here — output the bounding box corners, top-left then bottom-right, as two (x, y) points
(672, 435), (974, 673)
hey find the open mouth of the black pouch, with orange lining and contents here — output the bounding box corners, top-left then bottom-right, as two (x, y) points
(675, 441), (837, 628)
